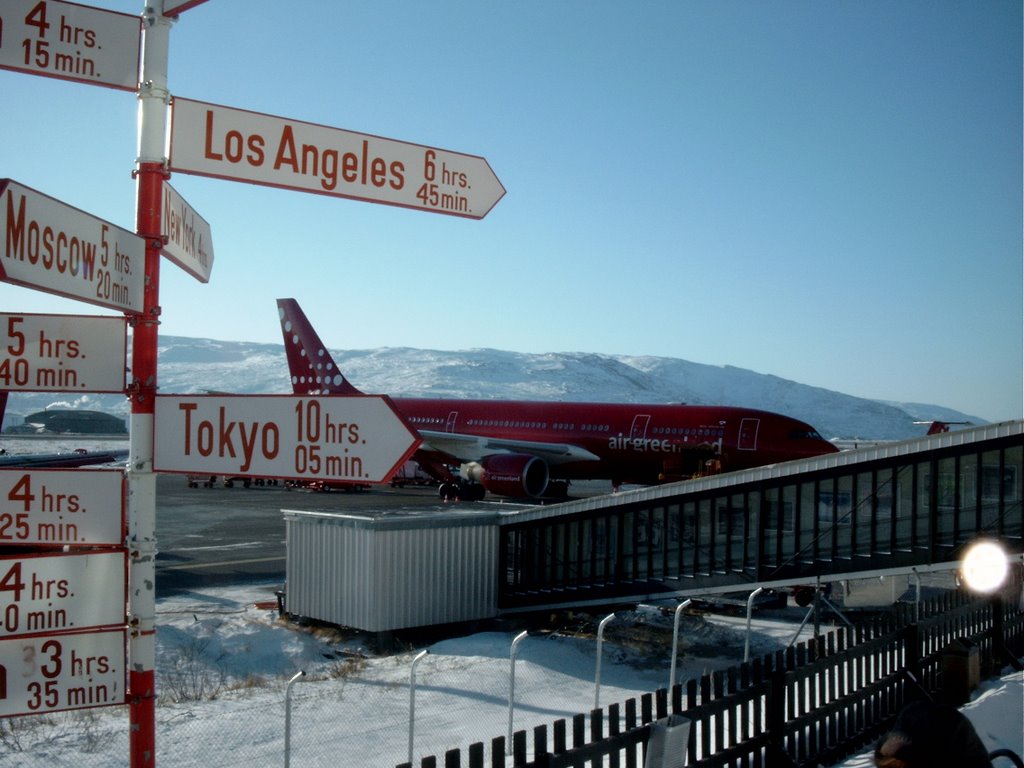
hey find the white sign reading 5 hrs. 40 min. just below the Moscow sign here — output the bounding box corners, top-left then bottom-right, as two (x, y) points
(0, 314), (128, 392)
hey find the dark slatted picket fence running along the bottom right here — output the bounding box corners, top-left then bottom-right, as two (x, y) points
(398, 588), (1024, 768)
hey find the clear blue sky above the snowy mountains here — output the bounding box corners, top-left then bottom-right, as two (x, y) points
(0, 0), (1024, 420)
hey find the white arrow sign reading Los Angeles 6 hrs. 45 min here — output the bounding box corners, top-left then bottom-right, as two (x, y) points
(170, 97), (505, 219)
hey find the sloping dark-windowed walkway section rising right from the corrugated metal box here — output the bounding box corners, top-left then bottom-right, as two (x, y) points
(498, 421), (1024, 611)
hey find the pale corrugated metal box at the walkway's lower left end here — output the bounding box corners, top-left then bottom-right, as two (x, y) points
(285, 510), (498, 632)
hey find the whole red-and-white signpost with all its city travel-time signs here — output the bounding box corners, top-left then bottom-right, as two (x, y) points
(0, 0), (505, 768)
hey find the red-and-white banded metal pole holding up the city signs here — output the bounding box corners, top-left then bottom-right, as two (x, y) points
(128, 2), (171, 768)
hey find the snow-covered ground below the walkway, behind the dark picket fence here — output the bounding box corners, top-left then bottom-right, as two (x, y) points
(0, 584), (1024, 768)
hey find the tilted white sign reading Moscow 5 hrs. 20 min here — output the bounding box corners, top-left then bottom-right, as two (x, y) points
(0, 179), (145, 313)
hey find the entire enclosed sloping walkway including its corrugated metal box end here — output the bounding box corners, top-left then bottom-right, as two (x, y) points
(285, 421), (1024, 632)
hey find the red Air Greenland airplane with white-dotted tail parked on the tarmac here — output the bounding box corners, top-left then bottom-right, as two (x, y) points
(278, 299), (837, 500)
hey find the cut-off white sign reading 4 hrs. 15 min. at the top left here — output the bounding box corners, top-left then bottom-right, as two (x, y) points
(0, 0), (142, 91)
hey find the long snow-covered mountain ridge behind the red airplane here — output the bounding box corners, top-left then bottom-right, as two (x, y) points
(4, 336), (983, 440)
